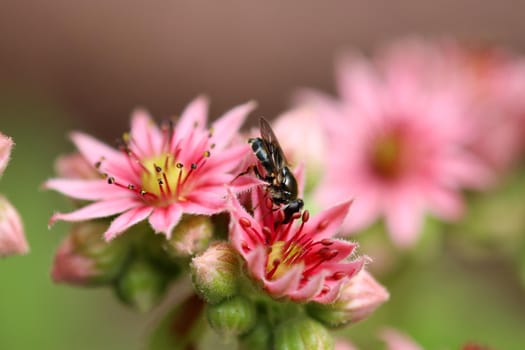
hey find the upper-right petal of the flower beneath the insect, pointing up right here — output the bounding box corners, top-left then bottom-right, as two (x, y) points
(303, 201), (352, 240)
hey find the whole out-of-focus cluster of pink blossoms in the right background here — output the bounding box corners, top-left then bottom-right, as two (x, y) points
(290, 39), (525, 247)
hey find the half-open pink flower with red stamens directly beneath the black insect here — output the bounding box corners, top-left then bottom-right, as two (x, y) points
(230, 187), (366, 303)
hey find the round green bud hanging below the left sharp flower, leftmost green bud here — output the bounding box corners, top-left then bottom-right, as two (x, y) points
(116, 258), (169, 312)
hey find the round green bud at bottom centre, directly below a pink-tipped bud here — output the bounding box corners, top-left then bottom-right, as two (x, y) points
(206, 296), (256, 336)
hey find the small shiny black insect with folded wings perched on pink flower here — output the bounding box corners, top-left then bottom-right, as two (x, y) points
(248, 118), (304, 224)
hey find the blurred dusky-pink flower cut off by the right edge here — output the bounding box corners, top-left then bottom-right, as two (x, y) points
(451, 45), (525, 172)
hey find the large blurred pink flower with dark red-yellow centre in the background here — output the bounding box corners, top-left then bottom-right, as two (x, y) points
(308, 43), (490, 246)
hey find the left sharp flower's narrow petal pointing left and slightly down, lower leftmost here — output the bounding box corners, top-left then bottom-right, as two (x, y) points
(49, 198), (141, 225)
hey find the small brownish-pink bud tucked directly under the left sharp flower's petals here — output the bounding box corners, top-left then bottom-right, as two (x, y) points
(164, 215), (213, 257)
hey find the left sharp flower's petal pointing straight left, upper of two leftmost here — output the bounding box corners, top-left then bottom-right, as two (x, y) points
(44, 179), (130, 200)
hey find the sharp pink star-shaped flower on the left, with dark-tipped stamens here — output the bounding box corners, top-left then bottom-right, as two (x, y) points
(45, 97), (255, 240)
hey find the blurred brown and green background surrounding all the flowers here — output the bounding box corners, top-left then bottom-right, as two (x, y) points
(0, 0), (525, 350)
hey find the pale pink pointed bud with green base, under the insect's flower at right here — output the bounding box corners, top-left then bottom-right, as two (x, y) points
(307, 270), (389, 327)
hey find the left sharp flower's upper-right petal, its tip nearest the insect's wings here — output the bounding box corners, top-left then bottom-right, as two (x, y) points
(212, 101), (257, 150)
